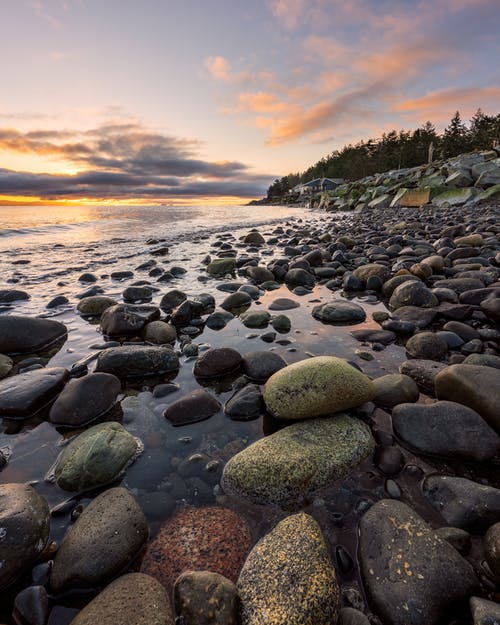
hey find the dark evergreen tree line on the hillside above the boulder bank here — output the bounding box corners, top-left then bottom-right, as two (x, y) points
(267, 109), (500, 199)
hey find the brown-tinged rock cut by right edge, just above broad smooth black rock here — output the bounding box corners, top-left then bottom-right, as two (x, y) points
(436, 364), (500, 433)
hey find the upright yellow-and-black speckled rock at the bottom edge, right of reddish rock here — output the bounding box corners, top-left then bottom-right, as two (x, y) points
(238, 513), (340, 625)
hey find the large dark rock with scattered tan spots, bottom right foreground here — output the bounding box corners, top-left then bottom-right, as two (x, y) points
(359, 499), (478, 625)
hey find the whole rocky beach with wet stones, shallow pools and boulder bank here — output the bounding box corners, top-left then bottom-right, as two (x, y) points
(0, 148), (500, 625)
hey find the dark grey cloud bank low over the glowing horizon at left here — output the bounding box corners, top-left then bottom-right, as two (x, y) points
(0, 123), (272, 201)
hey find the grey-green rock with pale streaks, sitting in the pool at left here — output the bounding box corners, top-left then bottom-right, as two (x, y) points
(55, 421), (138, 492)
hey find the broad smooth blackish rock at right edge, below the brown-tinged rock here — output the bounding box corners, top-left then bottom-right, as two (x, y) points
(392, 401), (500, 462)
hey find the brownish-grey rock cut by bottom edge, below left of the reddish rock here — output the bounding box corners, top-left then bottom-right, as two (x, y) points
(71, 573), (174, 625)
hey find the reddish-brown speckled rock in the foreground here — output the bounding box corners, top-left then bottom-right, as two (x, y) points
(141, 507), (253, 591)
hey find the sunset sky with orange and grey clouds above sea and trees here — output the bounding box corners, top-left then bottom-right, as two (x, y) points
(0, 0), (500, 204)
